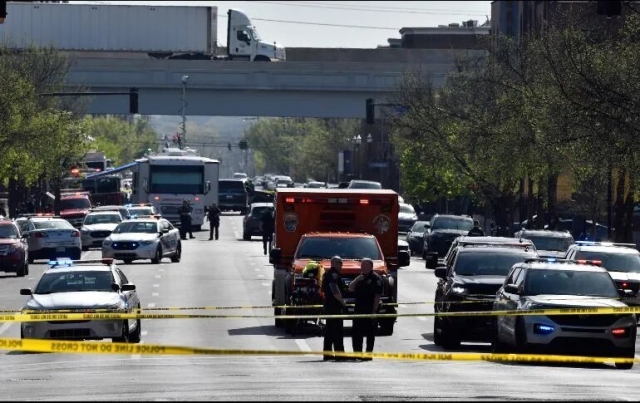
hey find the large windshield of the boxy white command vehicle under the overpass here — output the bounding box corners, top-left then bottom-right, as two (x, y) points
(149, 165), (204, 194)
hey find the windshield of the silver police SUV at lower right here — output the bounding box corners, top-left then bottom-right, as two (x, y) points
(524, 269), (619, 298)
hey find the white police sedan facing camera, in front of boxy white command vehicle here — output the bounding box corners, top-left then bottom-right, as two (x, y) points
(102, 217), (182, 264)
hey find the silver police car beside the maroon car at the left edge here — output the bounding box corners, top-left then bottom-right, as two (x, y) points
(16, 215), (82, 263)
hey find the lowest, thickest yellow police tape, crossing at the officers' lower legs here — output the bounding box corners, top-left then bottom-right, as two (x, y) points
(0, 338), (640, 364)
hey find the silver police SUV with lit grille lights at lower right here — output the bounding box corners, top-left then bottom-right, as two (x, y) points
(492, 259), (636, 369)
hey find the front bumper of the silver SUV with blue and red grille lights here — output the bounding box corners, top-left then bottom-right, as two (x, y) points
(524, 315), (636, 355)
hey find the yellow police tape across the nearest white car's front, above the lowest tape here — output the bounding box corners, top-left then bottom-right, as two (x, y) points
(0, 306), (640, 322)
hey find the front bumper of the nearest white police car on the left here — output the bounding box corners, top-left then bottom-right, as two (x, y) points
(21, 320), (124, 340)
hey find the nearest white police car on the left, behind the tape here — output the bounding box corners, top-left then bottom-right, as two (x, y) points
(20, 259), (142, 343)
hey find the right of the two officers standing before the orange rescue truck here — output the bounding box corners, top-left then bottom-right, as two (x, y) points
(349, 258), (383, 361)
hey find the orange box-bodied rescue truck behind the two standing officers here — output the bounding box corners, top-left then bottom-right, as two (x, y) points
(269, 188), (410, 335)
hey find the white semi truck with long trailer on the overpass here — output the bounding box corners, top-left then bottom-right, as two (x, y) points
(0, 2), (286, 61)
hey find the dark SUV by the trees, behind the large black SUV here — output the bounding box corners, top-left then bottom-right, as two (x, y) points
(422, 215), (473, 260)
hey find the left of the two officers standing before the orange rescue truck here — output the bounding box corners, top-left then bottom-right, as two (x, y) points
(322, 256), (347, 361)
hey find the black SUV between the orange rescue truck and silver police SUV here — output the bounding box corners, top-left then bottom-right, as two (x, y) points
(433, 243), (538, 349)
